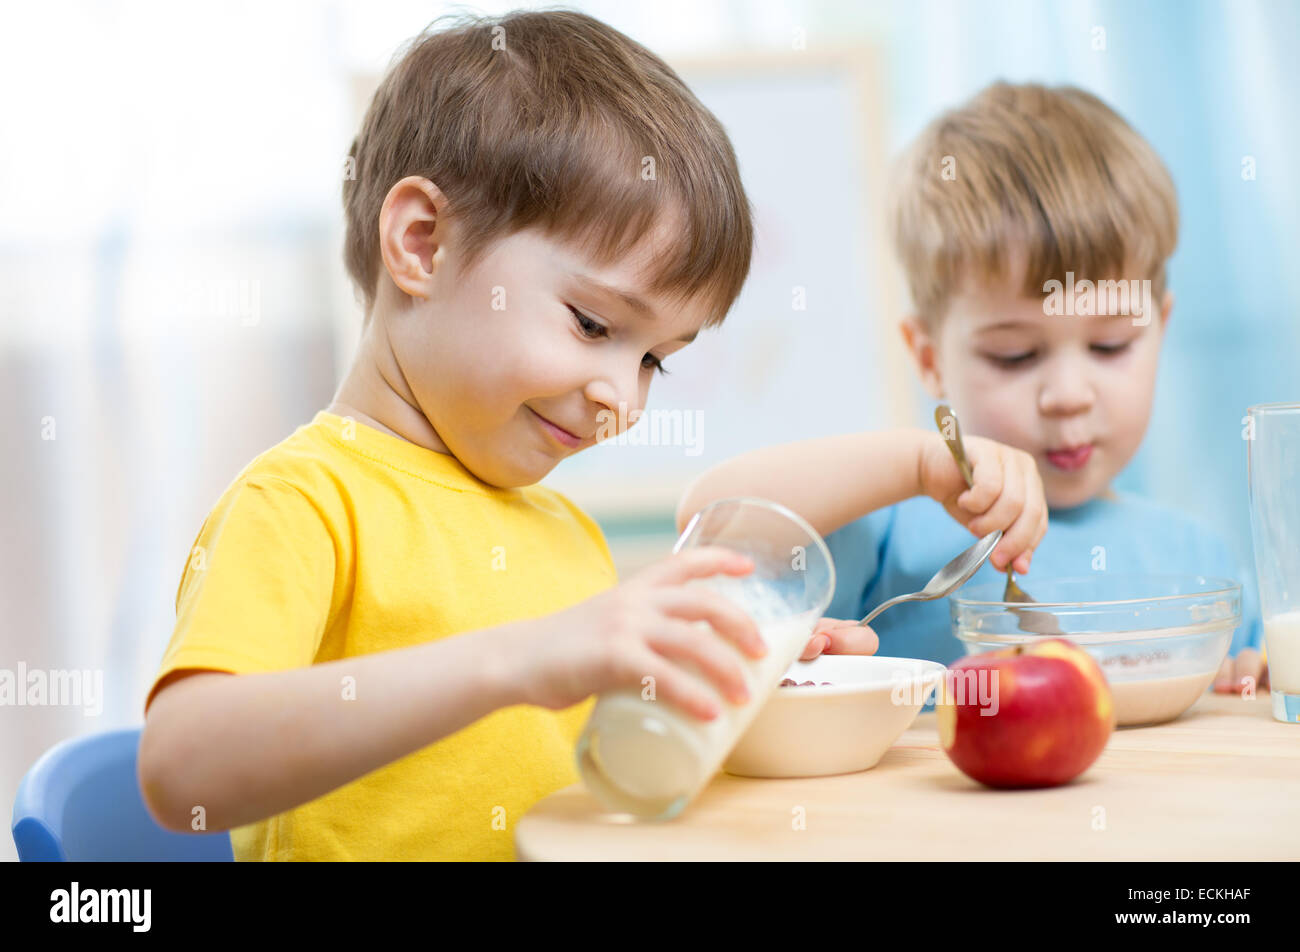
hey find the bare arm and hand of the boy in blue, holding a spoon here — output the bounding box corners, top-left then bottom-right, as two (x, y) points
(677, 429), (1048, 574)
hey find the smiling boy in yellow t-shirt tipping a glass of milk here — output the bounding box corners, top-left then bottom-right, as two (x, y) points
(139, 12), (1041, 860)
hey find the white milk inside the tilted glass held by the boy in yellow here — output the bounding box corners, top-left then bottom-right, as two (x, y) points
(577, 576), (820, 819)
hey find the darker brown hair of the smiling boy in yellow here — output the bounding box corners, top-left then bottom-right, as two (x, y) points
(343, 10), (754, 325)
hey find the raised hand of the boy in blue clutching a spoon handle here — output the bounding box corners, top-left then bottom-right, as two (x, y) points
(919, 433), (1048, 575)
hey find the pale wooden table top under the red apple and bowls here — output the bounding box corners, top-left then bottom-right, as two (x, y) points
(515, 692), (1300, 860)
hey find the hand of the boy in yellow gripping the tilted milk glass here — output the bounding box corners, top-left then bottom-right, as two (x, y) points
(504, 546), (767, 719)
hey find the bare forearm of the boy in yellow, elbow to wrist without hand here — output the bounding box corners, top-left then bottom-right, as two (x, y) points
(139, 629), (522, 832)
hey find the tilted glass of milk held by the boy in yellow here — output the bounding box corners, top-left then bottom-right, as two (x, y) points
(577, 498), (835, 819)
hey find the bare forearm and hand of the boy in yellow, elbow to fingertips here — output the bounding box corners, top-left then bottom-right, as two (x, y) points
(138, 548), (766, 832)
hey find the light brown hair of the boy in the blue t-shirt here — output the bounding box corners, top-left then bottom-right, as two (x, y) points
(891, 82), (1178, 321)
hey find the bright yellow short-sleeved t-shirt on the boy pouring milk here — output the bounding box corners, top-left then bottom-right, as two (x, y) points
(146, 412), (615, 860)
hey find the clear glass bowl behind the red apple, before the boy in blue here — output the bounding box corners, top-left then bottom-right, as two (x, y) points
(949, 574), (1242, 727)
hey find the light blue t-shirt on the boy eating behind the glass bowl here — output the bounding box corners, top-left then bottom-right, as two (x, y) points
(826, 493), (1261, 665)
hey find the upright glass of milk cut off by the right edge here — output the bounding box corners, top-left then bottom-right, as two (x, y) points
(1245, 403), (1300, 724)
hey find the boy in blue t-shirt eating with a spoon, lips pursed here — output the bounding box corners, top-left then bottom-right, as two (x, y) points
(679, 83), (1266, 691)
